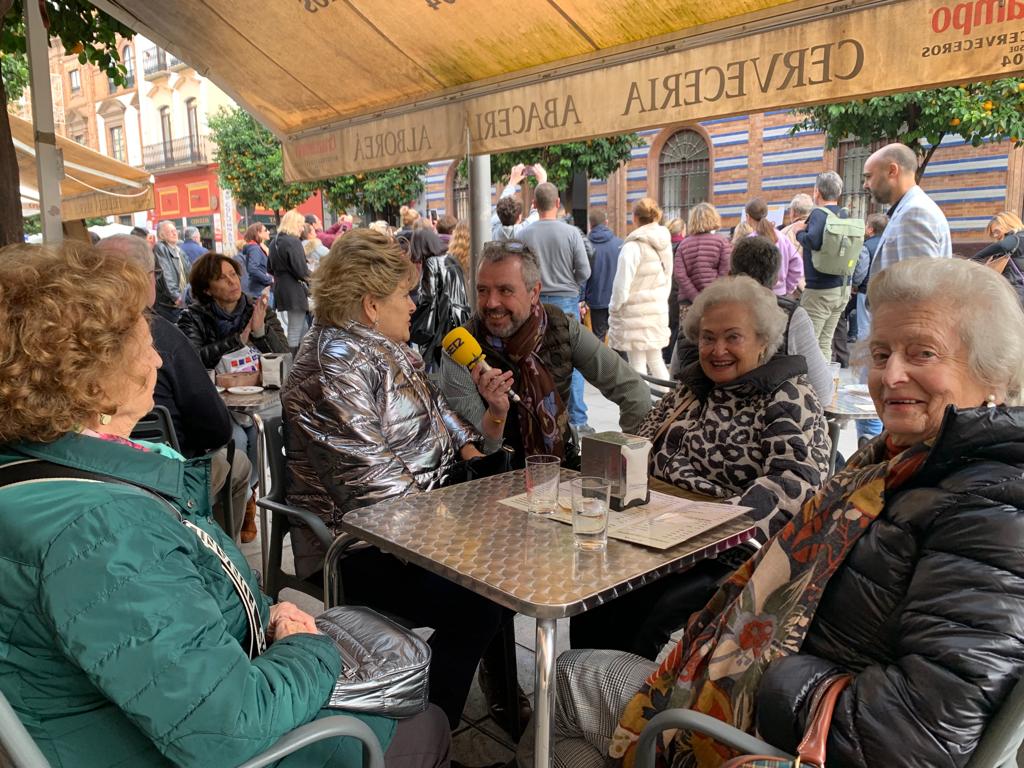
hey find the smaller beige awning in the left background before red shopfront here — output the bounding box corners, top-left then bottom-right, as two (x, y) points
(7, 115), (153, 221)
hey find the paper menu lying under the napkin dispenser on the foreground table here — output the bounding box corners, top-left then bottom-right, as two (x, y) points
(501, 482), (750, 549)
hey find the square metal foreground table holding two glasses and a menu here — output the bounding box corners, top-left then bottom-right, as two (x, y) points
(339, 469), (755, 768)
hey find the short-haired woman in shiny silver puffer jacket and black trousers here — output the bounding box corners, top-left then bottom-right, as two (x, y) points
(282, 229), (509, 728)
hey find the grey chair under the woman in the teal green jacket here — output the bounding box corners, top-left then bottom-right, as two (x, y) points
(0, 692), (384, 768)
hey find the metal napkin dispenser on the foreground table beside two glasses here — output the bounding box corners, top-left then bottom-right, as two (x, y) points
(581, 432), (651, 510)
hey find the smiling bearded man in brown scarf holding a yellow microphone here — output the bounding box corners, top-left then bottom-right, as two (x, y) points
(440, 240), (650, 469)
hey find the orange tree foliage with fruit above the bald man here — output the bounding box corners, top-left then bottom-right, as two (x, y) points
(791, 78), (1024, 181)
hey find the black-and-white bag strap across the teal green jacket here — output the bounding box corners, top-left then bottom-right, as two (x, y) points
(0, 459), (266, 658)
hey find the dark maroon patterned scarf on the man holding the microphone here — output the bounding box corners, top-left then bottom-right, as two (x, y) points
(479, 304), (568, 459)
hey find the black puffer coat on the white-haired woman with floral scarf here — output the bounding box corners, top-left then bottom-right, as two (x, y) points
(757, 408), (1024, 768)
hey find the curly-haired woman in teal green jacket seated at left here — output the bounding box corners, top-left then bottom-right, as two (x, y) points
(0, 245), (449, 768)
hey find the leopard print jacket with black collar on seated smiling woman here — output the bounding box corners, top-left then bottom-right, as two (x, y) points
(638, 355), (828, 542)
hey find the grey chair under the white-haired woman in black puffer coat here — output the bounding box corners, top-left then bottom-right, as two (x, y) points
(636, 678), (1024, 768)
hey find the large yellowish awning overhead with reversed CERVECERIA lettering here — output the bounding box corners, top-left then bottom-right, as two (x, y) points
(93, 0), (1024, 179)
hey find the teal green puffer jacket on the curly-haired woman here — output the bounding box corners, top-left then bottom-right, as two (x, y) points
(0, 434), (394, 768)
